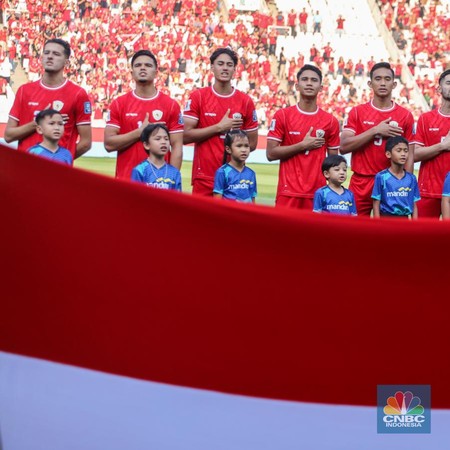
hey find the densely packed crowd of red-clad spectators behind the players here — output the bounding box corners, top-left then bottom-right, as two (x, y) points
(0, 0), (449, 128)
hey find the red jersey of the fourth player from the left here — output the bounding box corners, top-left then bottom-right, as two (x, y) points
(267, 105), (339, 198)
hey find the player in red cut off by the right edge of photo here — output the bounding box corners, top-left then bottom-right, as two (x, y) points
(413, 69), (450, 219)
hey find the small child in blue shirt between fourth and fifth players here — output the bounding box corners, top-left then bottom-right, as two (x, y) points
(313, 155), (357, 216)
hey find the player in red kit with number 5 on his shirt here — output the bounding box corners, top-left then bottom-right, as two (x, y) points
(340, 62), (414, 216)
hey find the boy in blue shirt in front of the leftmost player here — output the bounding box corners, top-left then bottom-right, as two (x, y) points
(27, 109), (73, 166)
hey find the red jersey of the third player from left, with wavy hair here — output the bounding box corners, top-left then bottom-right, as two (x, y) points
(184, 87), (258, 182)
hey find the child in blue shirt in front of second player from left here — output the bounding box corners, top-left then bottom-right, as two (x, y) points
(131, 123), (181, 191)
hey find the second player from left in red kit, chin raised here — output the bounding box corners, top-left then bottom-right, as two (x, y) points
(104, 50), (183, 180)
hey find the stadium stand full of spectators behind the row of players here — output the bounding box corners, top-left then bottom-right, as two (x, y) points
(0, 0), (450, 130)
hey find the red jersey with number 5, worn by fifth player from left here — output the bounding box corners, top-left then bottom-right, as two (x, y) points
(343, 101), (414, 176)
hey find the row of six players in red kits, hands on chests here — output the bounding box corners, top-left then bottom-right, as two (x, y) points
(5, 39), (450, 218)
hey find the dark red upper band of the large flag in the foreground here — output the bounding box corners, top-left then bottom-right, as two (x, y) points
(0, 147), (450, 408)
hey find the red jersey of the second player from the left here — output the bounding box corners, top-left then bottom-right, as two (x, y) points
(106, 91), (184, 180)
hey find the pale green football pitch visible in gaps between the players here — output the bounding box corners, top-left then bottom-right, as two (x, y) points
(74, 156), (282, 205)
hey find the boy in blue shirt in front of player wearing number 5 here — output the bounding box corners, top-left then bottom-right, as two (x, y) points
(372, 136), (420, 219)
